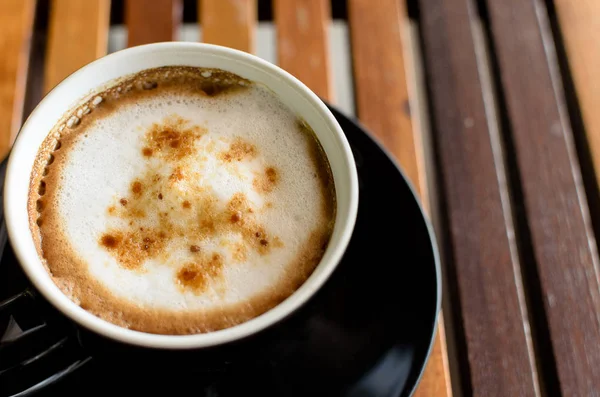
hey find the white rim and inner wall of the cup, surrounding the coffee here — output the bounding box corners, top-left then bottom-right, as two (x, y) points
(4, 42), (358, 349)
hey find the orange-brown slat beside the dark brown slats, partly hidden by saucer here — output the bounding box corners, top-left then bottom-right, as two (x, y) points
(346, 0), (451, 397)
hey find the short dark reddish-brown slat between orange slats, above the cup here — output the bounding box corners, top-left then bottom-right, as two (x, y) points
(125, 0), (183, 47)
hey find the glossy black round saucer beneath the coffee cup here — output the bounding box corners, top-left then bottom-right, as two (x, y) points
(0, 105), (440, 397)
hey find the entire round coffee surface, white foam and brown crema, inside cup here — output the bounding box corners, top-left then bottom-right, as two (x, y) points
(28, 66), (335, 334)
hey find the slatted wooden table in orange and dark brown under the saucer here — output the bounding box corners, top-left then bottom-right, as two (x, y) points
(0, 0), (600, 397)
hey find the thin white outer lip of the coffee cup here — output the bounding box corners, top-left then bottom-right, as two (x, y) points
(3, 42), (358, 350)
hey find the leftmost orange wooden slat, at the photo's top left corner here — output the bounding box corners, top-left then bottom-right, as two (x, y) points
(0, 0), (35, 158)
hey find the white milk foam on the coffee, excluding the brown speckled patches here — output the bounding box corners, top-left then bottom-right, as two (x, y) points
(42, 86), (330, 311)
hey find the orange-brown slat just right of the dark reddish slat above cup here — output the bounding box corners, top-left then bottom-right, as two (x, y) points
(198, 0), (257, 53)
